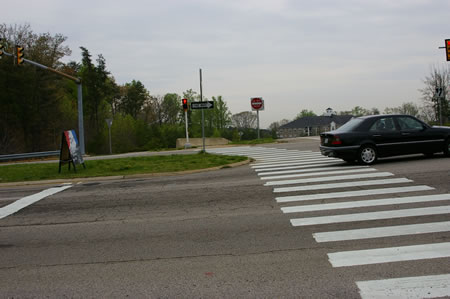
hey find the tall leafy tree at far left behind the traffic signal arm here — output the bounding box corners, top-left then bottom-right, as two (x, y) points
(0, 24), (70, 153)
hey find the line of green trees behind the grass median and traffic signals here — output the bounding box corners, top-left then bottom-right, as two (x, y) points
(0, 24), (266, 154)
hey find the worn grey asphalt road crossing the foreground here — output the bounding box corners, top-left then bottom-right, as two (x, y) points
(0, 139), (450, 298)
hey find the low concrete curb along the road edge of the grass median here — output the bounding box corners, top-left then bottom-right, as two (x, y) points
(0, 159), (251, 188)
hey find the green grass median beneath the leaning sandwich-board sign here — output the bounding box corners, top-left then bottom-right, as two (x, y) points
(0, 153), (247, 183)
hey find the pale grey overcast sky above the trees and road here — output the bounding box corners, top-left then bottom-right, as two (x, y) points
(0, 0), (450, 128)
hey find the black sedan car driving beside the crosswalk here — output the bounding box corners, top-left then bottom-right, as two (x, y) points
(320, 115), (450, 165)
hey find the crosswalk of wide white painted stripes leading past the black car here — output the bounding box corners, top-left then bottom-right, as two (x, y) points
(208, 147), (450, 298)
